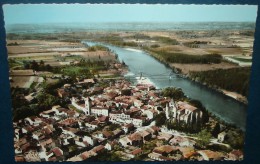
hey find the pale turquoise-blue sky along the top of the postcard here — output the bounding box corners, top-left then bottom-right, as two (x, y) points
(3, 4), (257, 24)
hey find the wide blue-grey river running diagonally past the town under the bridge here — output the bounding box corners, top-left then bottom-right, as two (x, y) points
(83, 42), (247, 130)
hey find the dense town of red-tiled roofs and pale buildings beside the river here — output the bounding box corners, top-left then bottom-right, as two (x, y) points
(13, 78), (243, 162)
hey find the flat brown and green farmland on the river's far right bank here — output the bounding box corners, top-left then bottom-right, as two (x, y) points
(86, 30), (253, 104)
